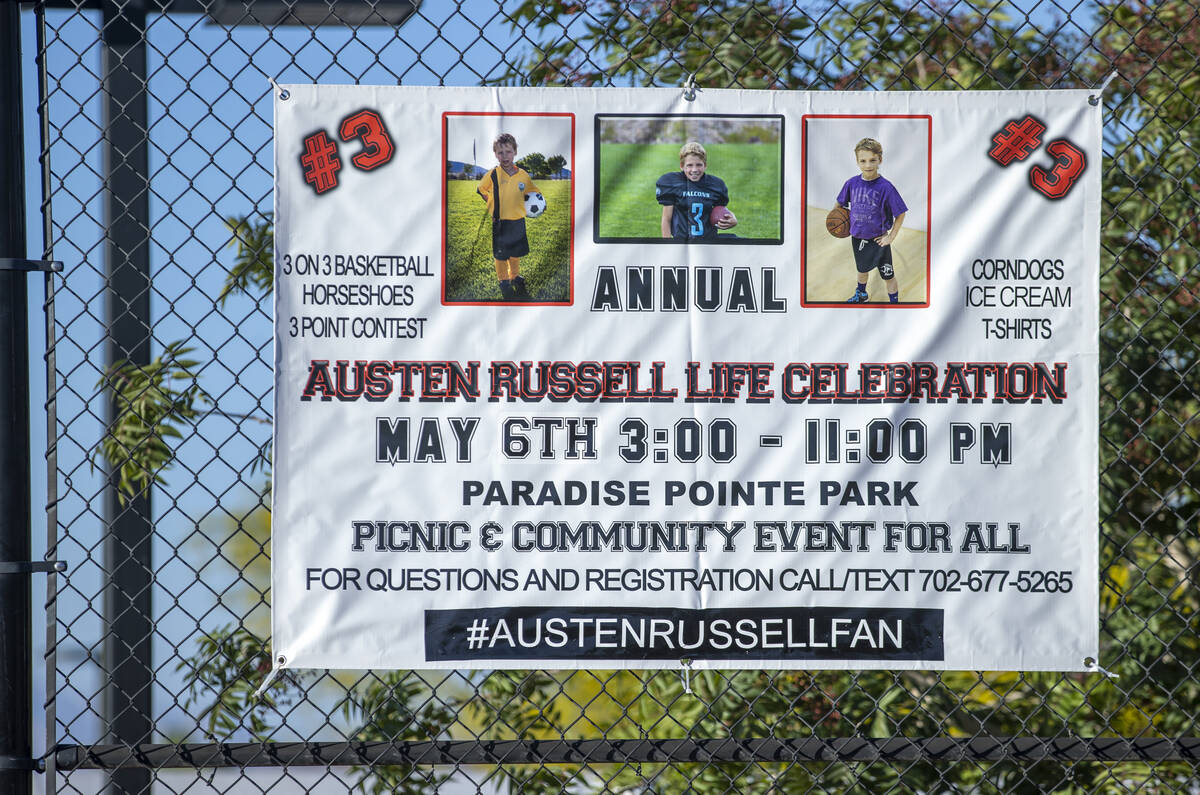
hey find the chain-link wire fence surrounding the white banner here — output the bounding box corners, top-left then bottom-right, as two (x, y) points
(24, 0), (1200, 794)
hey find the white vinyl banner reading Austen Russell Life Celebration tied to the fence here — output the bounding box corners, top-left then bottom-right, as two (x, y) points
(271, 85), (1102, 670)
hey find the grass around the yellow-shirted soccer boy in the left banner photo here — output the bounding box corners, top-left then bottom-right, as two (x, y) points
(445, 179), (571, 301)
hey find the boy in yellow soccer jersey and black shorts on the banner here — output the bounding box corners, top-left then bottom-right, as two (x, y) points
(475, 132), (541, 300)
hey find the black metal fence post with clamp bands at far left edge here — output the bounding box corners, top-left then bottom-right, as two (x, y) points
(0, 2), (34, 795)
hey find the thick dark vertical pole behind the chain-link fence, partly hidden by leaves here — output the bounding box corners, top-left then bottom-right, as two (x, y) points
(101, 0), (154, 793)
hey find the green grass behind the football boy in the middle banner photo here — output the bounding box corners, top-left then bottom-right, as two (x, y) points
(599, 143), (782, 239)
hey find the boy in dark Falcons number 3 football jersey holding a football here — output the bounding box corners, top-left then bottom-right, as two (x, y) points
(654, 141), (738, 241)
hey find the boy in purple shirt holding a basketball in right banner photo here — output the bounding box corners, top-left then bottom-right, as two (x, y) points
(836, 138), (908, 304)
